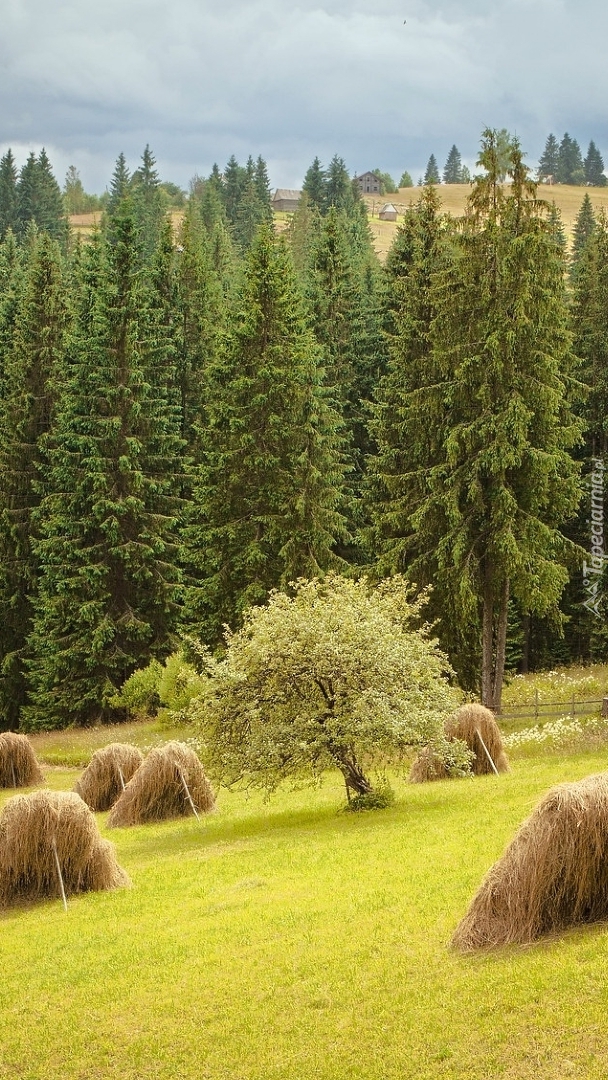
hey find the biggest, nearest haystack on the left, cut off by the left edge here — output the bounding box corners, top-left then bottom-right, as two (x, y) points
(0, 792), (130, 907)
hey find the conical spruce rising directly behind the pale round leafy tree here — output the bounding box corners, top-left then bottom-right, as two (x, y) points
(185, 227), (343, 644)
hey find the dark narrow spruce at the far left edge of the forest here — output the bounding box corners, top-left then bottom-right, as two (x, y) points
(0, 232), (68, 730)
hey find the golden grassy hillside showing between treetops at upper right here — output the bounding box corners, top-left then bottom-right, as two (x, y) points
(363, 184), (608, 258)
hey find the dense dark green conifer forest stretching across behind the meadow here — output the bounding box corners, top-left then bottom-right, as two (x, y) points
(0, 131), (608, 730)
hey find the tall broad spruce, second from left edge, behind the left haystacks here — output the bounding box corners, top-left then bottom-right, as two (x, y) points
(23, 200), (181, 730)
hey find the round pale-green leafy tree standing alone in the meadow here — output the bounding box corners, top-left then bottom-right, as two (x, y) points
(191, 575), (464, 799)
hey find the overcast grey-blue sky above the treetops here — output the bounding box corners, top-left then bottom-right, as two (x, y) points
(0, 0), (608, 193)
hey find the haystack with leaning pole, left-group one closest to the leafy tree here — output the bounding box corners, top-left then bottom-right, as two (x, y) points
(108, 742), (215, 827)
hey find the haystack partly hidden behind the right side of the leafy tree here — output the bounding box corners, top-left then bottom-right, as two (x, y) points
(408, 703), (509, 784)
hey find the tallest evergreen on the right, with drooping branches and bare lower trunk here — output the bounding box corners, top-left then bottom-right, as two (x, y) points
(371, 131), (581, 708)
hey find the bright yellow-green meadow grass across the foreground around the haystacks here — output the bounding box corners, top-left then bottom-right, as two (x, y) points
(0, 732), (608, 1080)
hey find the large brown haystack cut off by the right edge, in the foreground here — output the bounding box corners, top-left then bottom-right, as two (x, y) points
(451, 772), (608, 951)
